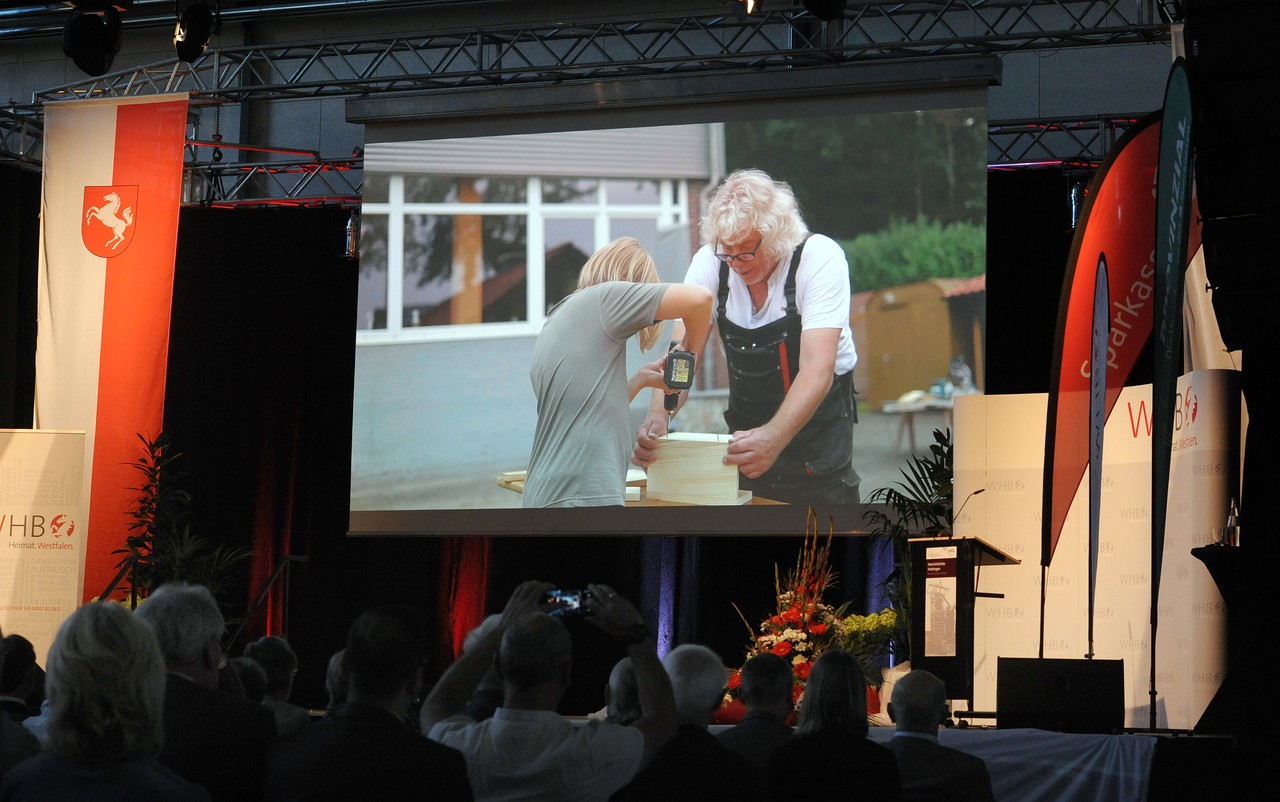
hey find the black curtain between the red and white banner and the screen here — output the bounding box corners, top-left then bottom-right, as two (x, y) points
(164, 207), (373, 705)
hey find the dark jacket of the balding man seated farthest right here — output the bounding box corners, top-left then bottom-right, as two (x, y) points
(890, 735), (995, 802)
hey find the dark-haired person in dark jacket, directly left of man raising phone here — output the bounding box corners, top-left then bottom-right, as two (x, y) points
(266, 605), (472, 802)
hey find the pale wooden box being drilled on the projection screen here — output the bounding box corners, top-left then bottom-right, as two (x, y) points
(645, 432), (751, 504)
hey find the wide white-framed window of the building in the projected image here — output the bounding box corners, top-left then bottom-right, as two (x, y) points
(356, 174), (685, 339)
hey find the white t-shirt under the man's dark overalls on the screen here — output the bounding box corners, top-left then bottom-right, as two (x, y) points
(685, 234), (858, 376)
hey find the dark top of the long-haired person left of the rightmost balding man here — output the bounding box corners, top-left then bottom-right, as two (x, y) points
(769, 730), (902, 802)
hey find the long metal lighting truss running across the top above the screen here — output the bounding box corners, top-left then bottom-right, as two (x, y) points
(22, 0), (1170, 104)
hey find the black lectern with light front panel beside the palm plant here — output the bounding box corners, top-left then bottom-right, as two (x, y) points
(906, 537), (1021, 712)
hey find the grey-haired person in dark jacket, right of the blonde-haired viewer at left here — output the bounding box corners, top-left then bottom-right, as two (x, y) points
(133, 582), (275, 802)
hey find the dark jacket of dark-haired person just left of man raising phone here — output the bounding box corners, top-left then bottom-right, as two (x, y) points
(266, 702), (472, 802)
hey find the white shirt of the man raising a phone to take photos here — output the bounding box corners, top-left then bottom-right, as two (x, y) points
(428, 707), (644, 802)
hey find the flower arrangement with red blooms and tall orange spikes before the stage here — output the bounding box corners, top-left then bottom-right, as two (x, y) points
(726, 510), (861, 704)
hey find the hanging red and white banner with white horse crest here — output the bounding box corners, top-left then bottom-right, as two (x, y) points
(36, 95), (187, 600)
